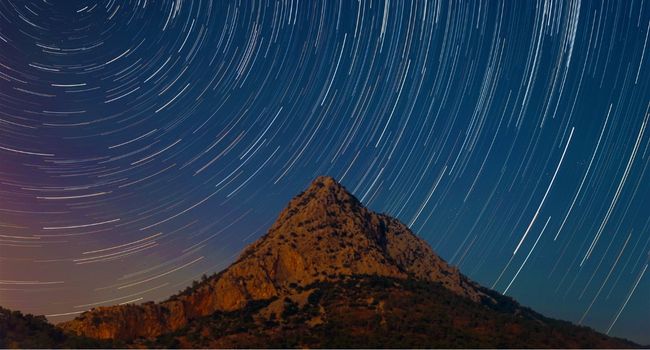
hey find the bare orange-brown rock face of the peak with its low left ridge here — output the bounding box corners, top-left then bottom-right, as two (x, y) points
(59, 177), (491, 340)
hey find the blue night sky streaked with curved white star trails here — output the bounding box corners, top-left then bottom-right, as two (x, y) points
(0, 0), (650, 344)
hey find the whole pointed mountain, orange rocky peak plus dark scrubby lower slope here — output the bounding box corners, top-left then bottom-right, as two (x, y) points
(2, 177), (638, 348)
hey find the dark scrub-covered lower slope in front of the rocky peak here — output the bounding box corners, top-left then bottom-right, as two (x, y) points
(141, 276), (638, 348)
